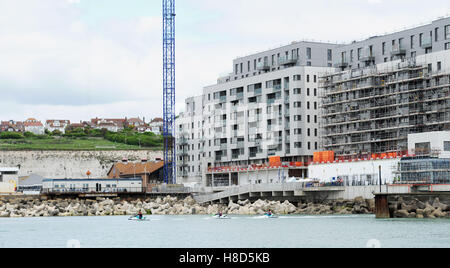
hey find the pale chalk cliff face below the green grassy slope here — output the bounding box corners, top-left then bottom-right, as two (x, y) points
(0, 150), (163, 179)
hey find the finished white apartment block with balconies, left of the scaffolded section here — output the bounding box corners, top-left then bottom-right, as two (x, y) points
(176, 42), (335, 187)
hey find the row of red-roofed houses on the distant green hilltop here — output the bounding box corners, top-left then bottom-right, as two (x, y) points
(0, 117), (163, 135)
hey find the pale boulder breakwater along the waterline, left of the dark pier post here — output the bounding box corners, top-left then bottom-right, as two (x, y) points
(0, 196), (374, 218)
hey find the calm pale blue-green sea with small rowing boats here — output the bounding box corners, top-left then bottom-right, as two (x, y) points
(0, 216), (450, 248)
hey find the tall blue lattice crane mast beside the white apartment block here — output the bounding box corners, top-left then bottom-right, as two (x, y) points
(163, 0), (176, 184)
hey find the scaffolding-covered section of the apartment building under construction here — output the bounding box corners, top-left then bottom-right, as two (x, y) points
(320, 50), (450, 158)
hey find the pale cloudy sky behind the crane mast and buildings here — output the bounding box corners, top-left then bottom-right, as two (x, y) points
(0, 0), (450, 122)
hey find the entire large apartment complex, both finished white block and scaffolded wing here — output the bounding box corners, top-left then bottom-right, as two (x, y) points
(176, 15), (450, 188)
